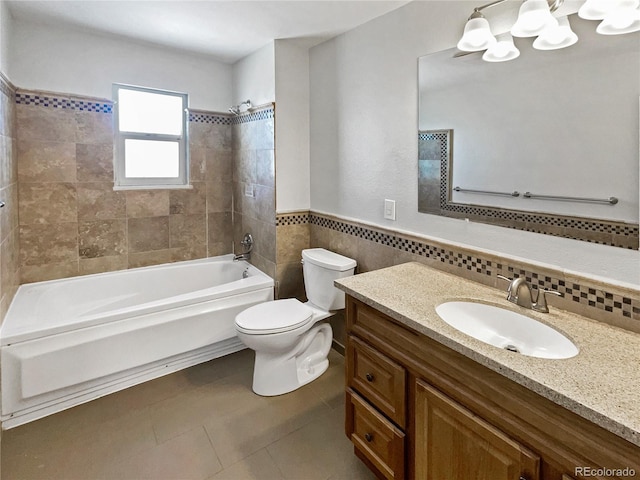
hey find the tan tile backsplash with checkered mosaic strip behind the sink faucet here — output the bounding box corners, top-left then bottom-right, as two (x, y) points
(309, 212), (640, 342)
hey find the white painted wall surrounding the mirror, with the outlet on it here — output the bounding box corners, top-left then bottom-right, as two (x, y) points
(310, 1), (640, 286)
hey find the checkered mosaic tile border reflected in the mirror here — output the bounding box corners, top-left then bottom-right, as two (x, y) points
(418, 131), (640, 249)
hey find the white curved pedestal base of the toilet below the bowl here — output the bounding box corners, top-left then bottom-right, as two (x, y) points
(253, 323), (333, 397)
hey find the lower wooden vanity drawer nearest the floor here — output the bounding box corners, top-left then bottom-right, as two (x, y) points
(345, 390), (405, 480)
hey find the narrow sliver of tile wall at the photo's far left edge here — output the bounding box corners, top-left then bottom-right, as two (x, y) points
(0, 73), (20, 323)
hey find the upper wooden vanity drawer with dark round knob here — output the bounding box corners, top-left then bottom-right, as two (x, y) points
(347, 335), (407, 428)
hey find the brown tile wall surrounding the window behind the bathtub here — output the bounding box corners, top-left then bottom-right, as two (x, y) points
(15, 90), (232, 283)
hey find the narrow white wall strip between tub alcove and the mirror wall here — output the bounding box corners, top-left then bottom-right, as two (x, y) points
(275, 40), (310, 213)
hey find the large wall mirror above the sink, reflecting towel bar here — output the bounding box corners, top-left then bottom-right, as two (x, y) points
(418, 15), (640, 249)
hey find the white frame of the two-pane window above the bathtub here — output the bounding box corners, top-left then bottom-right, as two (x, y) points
(112, 83), (190, 190)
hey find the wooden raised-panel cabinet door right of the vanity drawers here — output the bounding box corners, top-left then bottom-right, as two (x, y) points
(415, 380), (540, 480)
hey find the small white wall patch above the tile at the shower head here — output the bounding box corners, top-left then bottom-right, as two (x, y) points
(234, 42), (276, 107)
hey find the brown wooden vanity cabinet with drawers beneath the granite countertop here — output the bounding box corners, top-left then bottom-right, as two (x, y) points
(345, 296), (640, 480)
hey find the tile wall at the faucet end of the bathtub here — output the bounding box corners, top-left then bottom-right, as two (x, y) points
(229, 104), (276, 278)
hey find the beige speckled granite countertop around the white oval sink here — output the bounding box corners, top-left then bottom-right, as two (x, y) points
(335, 263), (640, 446)
